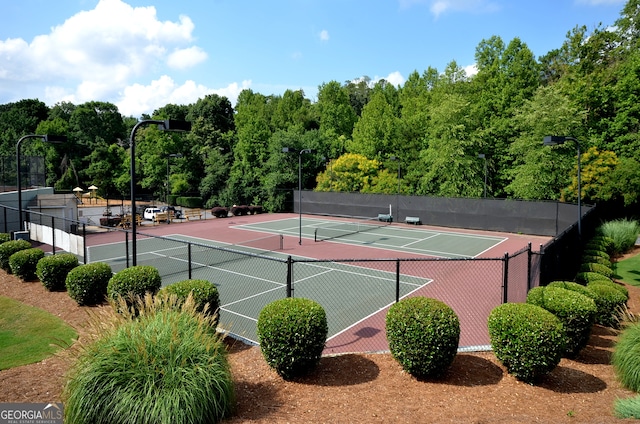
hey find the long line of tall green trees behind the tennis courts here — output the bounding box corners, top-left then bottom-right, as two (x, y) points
(0, 0), (640, 211)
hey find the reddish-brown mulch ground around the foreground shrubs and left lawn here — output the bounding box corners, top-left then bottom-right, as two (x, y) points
(0, 250), (640, 423)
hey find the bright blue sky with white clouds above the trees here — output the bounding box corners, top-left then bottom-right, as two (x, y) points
(0, 0), (625, 117)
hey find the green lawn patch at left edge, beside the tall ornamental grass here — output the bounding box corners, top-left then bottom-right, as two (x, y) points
(0, 296), (78, 370)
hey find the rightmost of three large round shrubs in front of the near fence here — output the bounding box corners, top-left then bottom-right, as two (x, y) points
(488, 303), (566, 383)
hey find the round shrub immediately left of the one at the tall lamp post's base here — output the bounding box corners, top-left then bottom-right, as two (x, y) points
(65, 262), (113, 305)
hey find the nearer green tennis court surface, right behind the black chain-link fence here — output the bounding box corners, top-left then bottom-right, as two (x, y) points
(88, 235), (431, 343)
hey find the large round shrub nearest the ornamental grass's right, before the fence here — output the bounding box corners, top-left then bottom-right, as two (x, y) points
(257, 298), (328, 380)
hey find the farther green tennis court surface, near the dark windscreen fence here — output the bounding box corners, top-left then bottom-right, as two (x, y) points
(234, 217), (506, 258)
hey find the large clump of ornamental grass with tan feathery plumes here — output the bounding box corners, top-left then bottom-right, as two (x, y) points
(62, 295), (235, 424)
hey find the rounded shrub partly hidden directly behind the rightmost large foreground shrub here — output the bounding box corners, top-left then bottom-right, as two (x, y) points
(527, 284), (598, 358)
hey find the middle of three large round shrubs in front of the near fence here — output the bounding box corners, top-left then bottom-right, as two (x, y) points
(386, 297), (460, 378)
